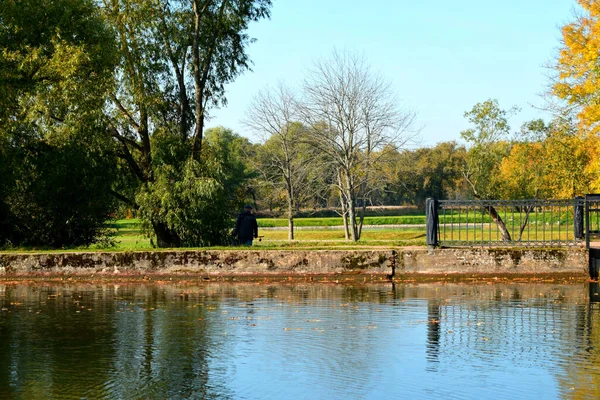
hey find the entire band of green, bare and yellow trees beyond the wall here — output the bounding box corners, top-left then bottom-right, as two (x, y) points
(0, 0), (600, 247)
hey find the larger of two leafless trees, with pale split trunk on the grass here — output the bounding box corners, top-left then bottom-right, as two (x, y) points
(299, 51), (418, 241)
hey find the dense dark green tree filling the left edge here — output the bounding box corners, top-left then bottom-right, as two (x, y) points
(0, 0), (115, 247)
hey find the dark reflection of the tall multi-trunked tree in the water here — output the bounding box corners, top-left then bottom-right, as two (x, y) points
(111, 286), (231, 398)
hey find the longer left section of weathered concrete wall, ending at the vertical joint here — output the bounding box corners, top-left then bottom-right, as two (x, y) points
(0, 250), (395, 276)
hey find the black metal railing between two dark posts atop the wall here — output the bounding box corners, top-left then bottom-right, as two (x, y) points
(427, 197), (584, 247)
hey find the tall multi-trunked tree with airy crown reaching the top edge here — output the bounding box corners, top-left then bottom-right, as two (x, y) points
(103, 0), (271, 247)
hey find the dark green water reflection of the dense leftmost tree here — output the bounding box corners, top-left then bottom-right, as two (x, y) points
(0, 286), (113, 398)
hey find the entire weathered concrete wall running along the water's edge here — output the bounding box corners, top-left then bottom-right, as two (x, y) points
(0, 247), (588, 277)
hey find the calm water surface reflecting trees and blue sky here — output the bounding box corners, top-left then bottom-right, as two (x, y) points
(0, 284), (600, 399)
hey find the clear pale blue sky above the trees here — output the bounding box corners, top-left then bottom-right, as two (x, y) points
(207, 0), (576, 146)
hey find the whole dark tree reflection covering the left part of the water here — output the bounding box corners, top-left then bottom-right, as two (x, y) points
(0, 286), (230, 398)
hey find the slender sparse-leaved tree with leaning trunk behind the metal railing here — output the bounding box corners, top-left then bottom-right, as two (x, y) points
(460, 100), (516, 241)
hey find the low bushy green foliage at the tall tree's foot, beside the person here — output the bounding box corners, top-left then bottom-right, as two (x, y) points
(138, 127), (249, 247)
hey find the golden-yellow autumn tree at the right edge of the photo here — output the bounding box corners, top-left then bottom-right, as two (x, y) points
(544, 0), (600, 198)
